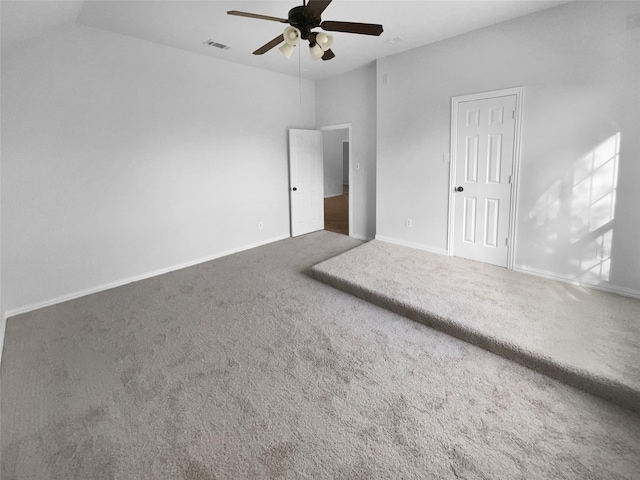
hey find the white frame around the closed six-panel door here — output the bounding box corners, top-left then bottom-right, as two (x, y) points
(447, 87), (524, 270)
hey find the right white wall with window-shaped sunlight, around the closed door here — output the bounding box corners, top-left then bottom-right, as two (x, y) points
(377, 2), (640, 293)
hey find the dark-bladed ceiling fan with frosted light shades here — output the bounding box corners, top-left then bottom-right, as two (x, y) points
(227, 0), (382, 60)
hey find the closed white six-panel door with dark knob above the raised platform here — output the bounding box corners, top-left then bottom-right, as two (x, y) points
(453, 95), (516, 267)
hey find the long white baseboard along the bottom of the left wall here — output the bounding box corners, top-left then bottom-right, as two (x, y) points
(4, 233), (291, 319)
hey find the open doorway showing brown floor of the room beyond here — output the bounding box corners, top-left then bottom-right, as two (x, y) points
(319, 124), (353, 235)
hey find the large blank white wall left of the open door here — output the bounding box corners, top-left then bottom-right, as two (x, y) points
(2, 25), (315, 313)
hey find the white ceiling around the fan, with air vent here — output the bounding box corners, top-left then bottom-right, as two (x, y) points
(2, 0), (567, 80)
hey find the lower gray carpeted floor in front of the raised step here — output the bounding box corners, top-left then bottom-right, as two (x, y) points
(1, 232), (640, 480)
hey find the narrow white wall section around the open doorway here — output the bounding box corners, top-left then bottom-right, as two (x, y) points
(316, 64), (376, 239)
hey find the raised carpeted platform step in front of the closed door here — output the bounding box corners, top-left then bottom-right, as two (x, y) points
(312, 240), (640, 414)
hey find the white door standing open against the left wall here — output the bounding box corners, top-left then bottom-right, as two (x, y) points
(289, 129), (324, 237)
